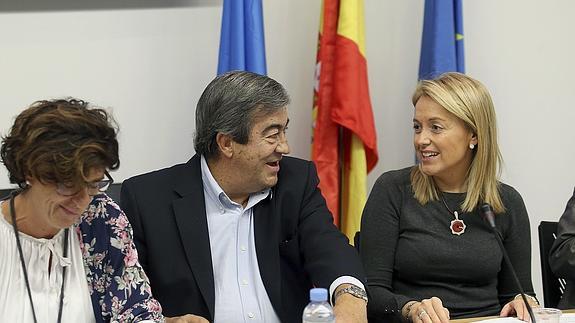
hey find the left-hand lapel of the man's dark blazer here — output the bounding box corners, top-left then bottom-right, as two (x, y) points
(173, 155), (215, 319)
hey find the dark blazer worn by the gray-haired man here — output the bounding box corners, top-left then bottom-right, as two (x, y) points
(121, 155), (365, 322)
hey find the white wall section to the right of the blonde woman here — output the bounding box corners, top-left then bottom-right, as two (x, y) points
(464, 0), (575, 299)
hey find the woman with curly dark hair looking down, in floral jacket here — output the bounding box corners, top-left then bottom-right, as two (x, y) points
(0, 99), (164, 322)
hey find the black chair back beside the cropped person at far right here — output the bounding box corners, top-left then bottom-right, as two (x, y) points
(538, 221), (565, 308)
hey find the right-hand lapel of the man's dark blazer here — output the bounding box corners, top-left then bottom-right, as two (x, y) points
(254, 195), (284, 318)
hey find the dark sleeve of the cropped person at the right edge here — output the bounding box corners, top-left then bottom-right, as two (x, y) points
(549, 192), (575, 309)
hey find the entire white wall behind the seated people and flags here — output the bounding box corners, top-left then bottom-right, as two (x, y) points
(0, 0), (575, 304)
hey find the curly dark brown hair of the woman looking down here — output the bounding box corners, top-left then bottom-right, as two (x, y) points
(0, 99), (120, 188)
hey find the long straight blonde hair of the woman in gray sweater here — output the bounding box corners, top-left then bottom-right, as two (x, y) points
(411, 72), (505, 213)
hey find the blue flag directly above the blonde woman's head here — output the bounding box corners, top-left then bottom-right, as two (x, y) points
(419, 0), (465, 80)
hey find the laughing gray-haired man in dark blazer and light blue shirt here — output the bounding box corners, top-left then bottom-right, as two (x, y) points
(121, 71), (367, 323)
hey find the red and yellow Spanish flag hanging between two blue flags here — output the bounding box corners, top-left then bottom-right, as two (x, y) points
(312, 0), (378, 241)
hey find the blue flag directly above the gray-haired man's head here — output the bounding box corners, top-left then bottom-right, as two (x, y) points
(218, 0), (267, 75)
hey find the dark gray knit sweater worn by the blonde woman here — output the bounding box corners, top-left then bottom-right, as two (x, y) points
(360, 168), (534, 319)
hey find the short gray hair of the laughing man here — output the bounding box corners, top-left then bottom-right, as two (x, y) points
(194, 71), (290, 158)
